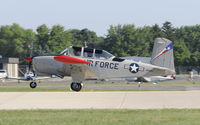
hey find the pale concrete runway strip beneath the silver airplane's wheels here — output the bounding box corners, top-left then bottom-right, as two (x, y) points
(0, 91), (200, 110)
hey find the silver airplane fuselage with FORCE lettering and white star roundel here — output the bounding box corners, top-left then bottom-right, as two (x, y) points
(32, 56), (172, 78)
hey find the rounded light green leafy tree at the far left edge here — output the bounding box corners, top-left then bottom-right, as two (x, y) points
(0, 23), (35, 64)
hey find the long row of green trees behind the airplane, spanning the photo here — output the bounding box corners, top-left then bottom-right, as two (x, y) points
(0, 21), (200, 73)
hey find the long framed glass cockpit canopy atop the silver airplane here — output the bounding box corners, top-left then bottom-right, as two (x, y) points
(60, 46), (114, 59)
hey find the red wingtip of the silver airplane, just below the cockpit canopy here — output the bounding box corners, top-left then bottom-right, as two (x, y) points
(54, 56), (91, 64)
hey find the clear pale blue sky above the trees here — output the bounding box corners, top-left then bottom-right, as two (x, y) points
(0, 0), (200, 36)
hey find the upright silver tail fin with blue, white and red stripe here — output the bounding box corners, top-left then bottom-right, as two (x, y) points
(151, 38), (175, 70)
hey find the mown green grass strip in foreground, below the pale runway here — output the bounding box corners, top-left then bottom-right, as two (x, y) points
(0, 109), (200, 125)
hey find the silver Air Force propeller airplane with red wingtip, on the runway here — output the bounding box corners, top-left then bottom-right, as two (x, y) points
(25, 38), (175, 91)
